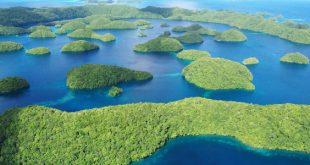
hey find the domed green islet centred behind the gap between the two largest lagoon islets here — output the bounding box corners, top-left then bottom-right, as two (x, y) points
(134, 37), (183, 53)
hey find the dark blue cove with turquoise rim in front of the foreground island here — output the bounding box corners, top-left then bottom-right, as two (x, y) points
(133, 136), (310, 165)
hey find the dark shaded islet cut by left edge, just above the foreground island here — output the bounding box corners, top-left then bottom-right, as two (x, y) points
(0, 77), (29, 94)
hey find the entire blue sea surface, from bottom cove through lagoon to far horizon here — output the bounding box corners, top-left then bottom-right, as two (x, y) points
(0, 0), (310, 165)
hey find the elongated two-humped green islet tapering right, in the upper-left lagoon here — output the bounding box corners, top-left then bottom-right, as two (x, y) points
(68, 29), (116, 42)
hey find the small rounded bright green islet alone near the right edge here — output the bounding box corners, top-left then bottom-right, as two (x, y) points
(280, 52), (309, 65)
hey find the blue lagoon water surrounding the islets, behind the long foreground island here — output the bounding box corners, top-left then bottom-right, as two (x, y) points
(0, 20), (310, 112)
